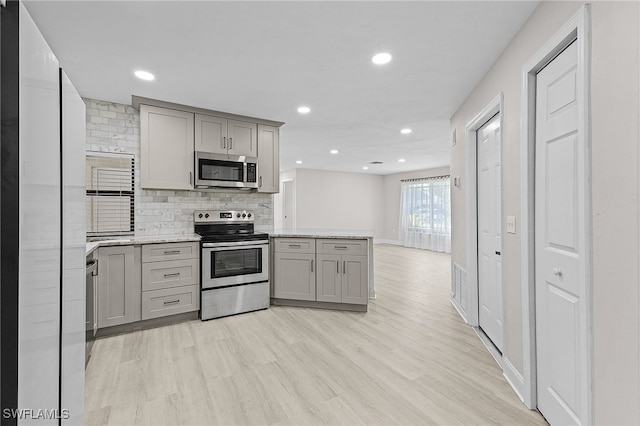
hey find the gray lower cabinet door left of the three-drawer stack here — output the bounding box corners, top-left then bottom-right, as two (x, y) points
(98, 246), (140, 328)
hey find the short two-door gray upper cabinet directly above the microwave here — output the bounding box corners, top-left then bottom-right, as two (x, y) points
(195, 114), (258, 157)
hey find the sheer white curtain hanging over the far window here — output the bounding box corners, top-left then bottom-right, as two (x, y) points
(400, 176), (451, 253)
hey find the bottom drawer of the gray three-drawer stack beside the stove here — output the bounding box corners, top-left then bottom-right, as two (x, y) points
(142, 285), (200, 320)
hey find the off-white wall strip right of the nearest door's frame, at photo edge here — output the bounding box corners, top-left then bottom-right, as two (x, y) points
(591, 2), (640, 424)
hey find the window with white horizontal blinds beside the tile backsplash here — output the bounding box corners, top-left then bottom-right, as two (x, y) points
(86, 152), (134, 236)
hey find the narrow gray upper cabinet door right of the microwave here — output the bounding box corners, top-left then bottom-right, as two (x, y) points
(258, 124), (280, 193)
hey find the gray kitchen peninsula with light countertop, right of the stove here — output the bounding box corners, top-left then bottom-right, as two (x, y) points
(270, 228), (375, 312)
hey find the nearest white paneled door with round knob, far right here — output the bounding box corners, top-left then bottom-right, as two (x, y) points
(535, 42), (588, 424)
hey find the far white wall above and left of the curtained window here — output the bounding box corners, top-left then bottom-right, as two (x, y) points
(381, 167), (449, 244)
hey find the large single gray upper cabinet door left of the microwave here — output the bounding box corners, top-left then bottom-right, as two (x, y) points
(140, 105), (194, 190)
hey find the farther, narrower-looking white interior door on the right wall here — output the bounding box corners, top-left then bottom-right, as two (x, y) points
(476, 113), (502, 352)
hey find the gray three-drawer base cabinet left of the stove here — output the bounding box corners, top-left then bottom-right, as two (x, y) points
(142, 242), (200, 320)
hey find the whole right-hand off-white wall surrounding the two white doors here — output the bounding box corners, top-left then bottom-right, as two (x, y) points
(451, 1), (640, 424)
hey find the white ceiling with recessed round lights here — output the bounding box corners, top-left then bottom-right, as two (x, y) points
(27, 1), (538, 174)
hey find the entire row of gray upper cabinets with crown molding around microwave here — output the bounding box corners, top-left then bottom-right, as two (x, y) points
(132, 96), (284, 193)
